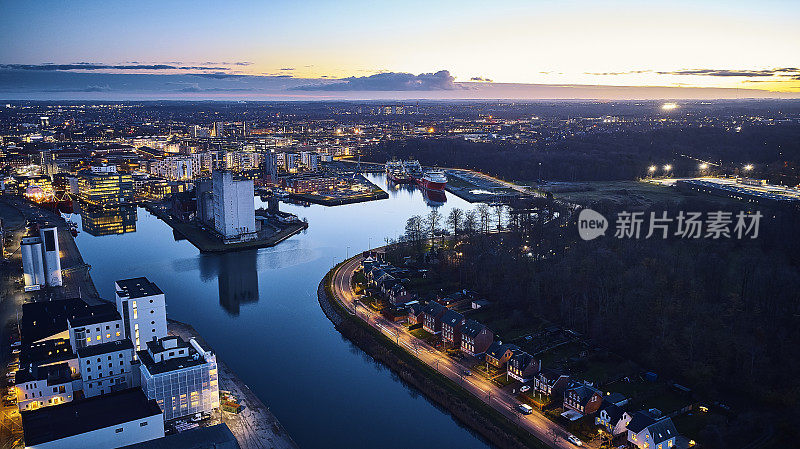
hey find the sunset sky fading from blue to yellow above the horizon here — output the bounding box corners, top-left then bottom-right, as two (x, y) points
(0, 0), (800, 99)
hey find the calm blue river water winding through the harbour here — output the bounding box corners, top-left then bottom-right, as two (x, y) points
(73, 175), (488, 448)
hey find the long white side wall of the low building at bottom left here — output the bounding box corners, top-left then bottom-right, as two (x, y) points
(26, 414), (164, 449)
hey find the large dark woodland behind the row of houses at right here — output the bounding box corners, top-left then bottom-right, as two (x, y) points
(392, 202), (800, 447)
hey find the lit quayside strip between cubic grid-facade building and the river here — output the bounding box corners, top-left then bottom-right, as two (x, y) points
(167, 320), (298, 449)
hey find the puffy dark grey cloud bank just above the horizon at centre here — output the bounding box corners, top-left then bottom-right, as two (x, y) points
(292, 70), (458, 91)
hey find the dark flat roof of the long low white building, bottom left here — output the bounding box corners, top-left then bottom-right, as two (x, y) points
(21, 388), (161, 446)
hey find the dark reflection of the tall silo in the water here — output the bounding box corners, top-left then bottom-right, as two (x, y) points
(215, 250), (258, 315)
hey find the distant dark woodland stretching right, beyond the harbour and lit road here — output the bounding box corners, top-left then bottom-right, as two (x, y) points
(365, 124), (800, 185)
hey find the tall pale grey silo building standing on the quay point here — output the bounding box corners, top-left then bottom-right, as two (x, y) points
(213, 170), (256, 239)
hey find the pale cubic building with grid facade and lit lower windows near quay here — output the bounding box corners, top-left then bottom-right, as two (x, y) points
(138, 336), (219, 421)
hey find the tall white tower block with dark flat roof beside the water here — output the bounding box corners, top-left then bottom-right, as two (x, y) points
(114, 277), (167, 358)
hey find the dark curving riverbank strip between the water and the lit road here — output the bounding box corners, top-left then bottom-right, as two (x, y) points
(317, 261), (546, 449)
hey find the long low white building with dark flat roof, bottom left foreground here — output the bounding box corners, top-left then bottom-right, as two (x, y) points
(22, 388), (164, 449)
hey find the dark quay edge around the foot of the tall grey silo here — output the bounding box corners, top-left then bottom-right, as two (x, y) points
(144, 203), (308, 253)
